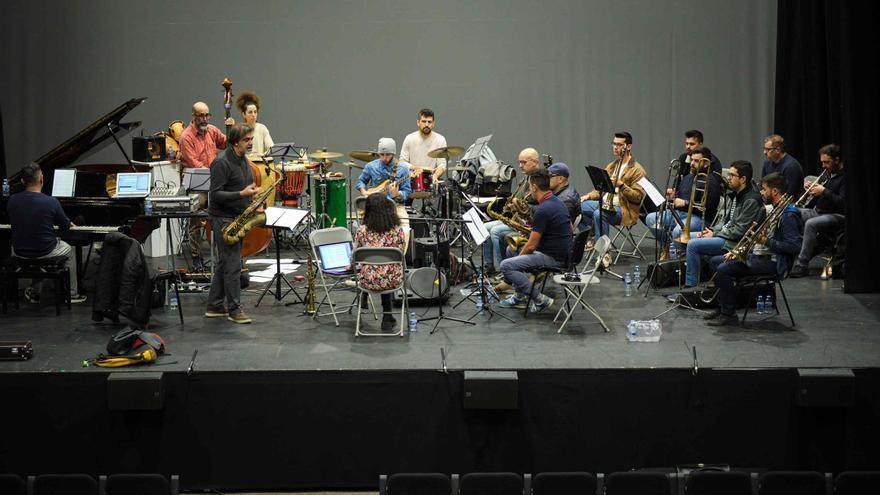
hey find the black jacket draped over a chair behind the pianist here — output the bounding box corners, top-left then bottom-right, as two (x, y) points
(92, 232), (156, 328)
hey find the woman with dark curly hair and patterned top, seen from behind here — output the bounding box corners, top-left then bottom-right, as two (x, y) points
(354, 193), (405, 330)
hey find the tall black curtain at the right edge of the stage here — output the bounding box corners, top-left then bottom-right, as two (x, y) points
(774, 0), (880, 292)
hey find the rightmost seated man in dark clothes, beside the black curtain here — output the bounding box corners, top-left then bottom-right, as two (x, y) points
(789, 144), (846, 278)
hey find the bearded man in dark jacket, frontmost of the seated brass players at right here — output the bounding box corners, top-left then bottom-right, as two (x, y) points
(703, 172), (804, 326)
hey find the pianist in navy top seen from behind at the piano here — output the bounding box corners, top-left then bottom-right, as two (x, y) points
(7, 163), (86, 303)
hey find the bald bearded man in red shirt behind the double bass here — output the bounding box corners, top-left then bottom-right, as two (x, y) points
(180, 101), (235, 258)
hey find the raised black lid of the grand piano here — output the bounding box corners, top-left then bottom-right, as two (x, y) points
(34, 97), (147, 172)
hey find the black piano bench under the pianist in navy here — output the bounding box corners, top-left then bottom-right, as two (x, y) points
(0, 256), (70, 316)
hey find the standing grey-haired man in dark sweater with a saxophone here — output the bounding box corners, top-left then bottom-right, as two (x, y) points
(205, 123), (259, 323)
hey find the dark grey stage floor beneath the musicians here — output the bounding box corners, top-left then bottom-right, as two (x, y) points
(0, 246), (880, 372)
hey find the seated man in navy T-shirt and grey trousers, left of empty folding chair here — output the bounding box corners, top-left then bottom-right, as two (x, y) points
(501, 168), (572, 313)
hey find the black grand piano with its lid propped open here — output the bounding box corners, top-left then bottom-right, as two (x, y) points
(0, 98), (159, 264)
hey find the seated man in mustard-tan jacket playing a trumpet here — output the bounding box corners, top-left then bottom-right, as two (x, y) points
(578, 131), (645, 239)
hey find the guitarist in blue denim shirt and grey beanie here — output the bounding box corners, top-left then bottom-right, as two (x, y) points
(355, 138), (412, 251)
